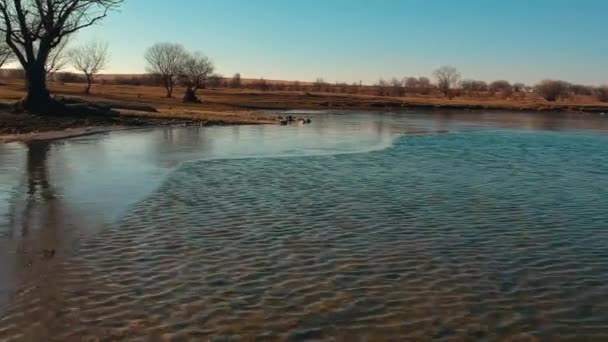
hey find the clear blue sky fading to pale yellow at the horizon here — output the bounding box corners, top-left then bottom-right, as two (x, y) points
(76, 0), (608, 84)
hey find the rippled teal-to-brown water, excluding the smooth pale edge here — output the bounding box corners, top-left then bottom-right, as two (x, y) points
(0, 133), (608, 341)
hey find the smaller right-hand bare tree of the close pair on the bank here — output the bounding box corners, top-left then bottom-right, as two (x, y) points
(180, 52), (214, 102)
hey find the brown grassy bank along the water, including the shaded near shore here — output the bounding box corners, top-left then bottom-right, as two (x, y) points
(0, 82), (608, 143)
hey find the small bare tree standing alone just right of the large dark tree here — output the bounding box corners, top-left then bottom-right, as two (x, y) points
(68, 40), (108, 94)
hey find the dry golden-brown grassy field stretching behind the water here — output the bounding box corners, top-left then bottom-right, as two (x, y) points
(0, 81), (608, 133)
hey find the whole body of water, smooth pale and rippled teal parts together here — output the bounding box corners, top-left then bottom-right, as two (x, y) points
(0, 112), (608, 341)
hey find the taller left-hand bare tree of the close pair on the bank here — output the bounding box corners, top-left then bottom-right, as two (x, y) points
(145, 43), (188, 97)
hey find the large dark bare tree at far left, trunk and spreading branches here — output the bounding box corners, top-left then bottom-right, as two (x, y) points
(0, 0), (123, 113)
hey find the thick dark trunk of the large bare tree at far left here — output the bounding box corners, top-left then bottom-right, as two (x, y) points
(20, 63), (52, 113)
